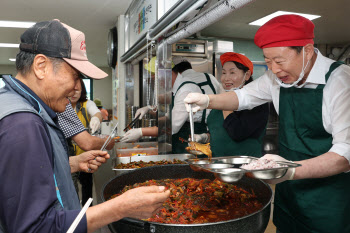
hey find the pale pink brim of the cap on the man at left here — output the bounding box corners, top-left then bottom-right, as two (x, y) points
(63, 58), (108, 79)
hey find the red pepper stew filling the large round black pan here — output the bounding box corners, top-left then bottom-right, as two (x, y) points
(111, 178), (263, 224)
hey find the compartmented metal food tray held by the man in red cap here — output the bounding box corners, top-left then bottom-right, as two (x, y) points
(185, 156), (301, 183)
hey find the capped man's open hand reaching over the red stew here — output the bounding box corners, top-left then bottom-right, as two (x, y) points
(116, 186), (170, 219)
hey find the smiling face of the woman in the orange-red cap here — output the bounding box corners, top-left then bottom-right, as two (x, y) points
(221, 62), (250, 90)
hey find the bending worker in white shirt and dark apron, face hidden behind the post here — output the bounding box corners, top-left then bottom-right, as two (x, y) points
(121, 56), (220, 154)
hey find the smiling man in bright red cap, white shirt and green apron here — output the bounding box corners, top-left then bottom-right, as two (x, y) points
(185, 15), (350, 233)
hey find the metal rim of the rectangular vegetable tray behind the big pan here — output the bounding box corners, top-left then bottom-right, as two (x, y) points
(112, 154), (195, 175)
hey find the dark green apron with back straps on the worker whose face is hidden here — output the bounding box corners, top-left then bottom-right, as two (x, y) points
(172, 73), (216, 154)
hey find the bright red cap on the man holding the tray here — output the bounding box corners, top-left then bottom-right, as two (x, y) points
(254, 15), (315, 49)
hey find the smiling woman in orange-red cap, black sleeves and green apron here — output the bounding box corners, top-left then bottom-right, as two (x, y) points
(194, 52), (269, 157)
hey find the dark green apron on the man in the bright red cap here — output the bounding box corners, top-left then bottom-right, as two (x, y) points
(273, 62), (350, 233)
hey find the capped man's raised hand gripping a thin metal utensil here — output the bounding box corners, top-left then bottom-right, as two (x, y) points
(73, 150), (110, 173)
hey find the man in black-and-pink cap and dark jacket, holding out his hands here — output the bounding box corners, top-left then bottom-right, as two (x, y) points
(0, 20), (169, 233)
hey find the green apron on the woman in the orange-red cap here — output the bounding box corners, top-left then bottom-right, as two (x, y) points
(207, 109), (265, 157)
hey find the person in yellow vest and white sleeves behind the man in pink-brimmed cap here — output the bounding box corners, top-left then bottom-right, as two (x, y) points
(70, 78), (102, 205)
